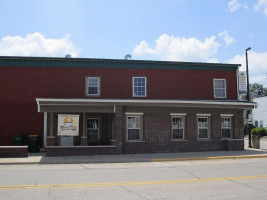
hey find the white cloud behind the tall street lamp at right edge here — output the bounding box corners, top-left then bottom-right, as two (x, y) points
(229, 51), (267, 87)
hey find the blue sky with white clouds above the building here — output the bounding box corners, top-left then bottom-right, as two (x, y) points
(0, 0), (267, 87)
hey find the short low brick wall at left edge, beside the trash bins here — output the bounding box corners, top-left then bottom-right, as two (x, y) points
(0, 146), (28, 158)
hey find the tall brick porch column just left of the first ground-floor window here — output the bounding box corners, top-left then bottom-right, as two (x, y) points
(114, 105), (125, 154)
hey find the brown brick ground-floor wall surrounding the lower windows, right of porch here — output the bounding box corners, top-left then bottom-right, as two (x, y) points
(123, 111), (244, 153)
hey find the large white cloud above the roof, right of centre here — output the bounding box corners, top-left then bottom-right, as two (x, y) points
(133, 34), (220, 62)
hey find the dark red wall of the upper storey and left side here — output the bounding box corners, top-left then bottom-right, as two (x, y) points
(0, 67), (237, 145)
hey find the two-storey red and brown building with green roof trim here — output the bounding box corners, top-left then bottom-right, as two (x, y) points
(0, 57), (254, 156)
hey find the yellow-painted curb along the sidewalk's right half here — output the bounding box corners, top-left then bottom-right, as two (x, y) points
(150, 154), (267, 162)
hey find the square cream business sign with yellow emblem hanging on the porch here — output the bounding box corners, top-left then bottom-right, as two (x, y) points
(57, 114), (79, 136)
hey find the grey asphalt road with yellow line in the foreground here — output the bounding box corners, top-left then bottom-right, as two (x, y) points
(0, 158), (267, 200)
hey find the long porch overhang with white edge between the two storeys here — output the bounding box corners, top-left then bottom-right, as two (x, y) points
(36, 98), (257, 113)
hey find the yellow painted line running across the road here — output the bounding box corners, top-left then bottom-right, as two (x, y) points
(0, 175), (267, 190)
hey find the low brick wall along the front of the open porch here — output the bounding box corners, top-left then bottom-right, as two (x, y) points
(46, 146), (118, 157)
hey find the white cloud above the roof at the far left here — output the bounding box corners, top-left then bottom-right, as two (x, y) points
(0, 33), (80, 57)
